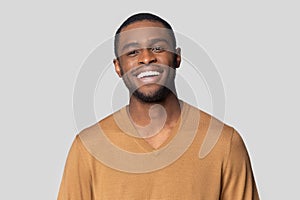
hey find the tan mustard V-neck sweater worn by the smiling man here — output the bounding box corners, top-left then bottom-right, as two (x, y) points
(58, 103), (259, 200)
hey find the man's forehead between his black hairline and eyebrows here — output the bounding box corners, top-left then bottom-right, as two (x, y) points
(119, 20), (172, 48)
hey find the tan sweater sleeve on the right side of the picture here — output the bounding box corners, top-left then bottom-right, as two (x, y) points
(221, 130), (259, 200)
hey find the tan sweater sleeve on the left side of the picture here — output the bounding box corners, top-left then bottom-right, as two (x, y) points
(57, 135), (92, 200)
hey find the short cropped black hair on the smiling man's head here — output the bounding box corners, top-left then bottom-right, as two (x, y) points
(114, 13), (176, 58)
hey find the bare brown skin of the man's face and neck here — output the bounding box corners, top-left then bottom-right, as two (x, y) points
(113, 20), (181, 149)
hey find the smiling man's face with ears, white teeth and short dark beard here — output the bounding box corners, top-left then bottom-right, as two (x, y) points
(114, 20), (181, 102)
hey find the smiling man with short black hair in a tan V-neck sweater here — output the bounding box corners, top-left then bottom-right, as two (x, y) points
(58, 13), (259, 200)
